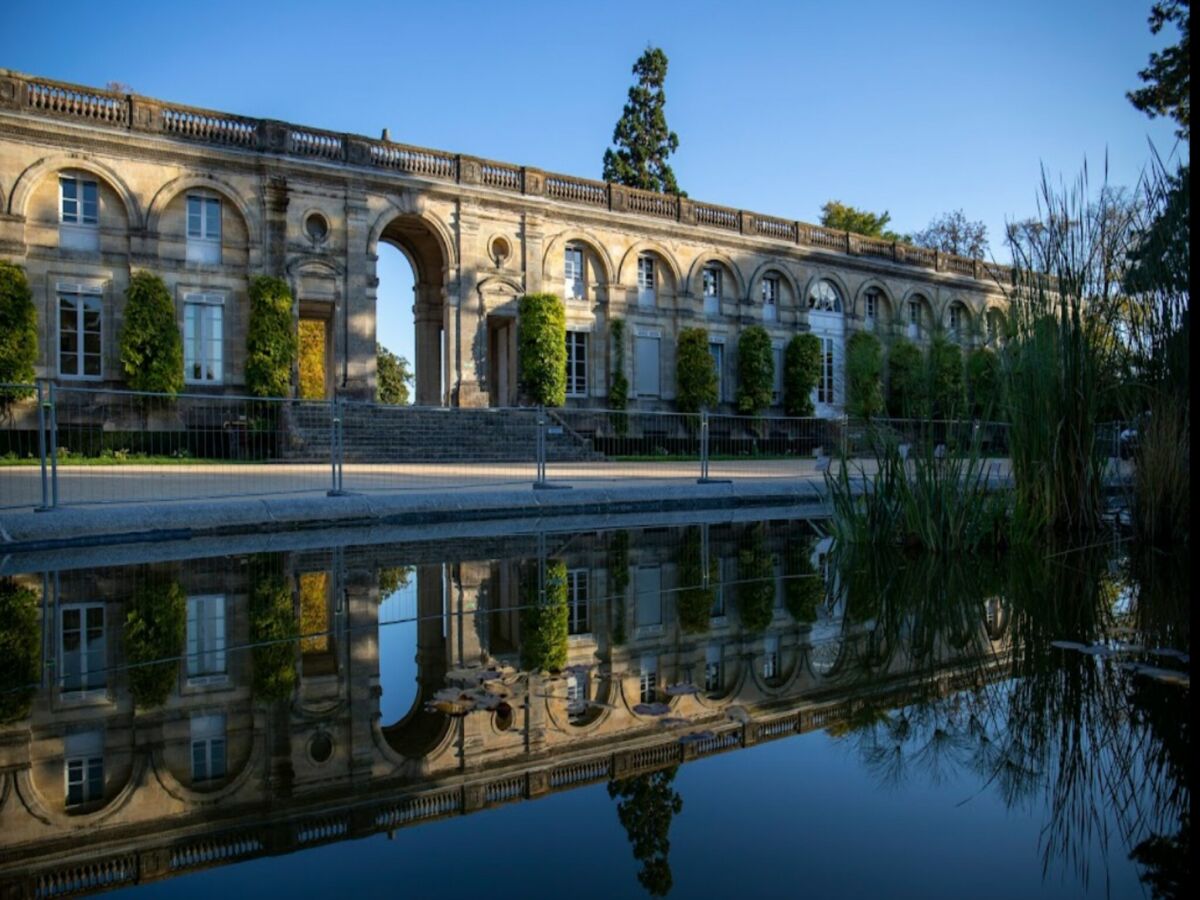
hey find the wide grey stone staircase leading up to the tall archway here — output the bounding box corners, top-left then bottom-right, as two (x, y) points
(283, 403), (604, 462)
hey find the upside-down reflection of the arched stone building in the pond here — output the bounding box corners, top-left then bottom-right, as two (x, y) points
(0, 523), (1002, 895)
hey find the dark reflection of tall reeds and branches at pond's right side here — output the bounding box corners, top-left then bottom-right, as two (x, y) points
(839, 548), (1190, 889)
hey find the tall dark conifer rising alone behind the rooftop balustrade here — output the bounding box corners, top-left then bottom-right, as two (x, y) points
(604, 47), (686, 197)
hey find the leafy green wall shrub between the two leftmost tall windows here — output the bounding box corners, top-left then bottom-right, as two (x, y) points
(120, 271), (184, 396)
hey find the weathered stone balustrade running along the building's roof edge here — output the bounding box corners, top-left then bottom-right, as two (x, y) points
(0, 68), (1012, 283)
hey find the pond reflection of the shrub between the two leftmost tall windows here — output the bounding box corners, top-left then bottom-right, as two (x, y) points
(125, 572), (187, 709)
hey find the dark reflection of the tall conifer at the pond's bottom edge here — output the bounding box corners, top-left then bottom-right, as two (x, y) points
(608, 767), (683, 896)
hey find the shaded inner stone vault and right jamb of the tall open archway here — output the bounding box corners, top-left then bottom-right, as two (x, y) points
(370, 212), (452, 406)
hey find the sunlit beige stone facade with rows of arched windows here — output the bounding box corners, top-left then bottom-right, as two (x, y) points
(0, 70), (1008, 414)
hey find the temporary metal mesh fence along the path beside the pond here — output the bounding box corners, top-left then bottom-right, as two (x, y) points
(7, 382), (1121, 509)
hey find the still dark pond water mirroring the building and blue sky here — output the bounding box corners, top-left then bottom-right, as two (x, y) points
(0, 520), (1190, 898)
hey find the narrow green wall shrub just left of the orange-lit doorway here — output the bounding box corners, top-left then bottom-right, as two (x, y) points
(246, 275), (300, 397)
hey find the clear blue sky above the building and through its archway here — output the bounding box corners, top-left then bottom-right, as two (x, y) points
(7, 0), (1176, 367)
